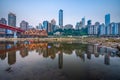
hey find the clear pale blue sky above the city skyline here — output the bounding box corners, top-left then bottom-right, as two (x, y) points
(0, 0), (120, 27)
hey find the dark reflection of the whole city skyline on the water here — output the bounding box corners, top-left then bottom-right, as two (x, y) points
(0, 41), (118, 66)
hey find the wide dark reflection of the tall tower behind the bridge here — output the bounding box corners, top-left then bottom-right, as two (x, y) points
(8, 51), (16, 65)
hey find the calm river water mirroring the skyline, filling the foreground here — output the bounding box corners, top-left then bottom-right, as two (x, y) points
(0, 41), (120, 80)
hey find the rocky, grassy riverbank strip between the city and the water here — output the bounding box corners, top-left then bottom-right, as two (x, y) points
(0, 37), (120, 50)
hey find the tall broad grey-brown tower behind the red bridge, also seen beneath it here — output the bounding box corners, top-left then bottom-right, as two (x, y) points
(7, 13), (16, 34)
